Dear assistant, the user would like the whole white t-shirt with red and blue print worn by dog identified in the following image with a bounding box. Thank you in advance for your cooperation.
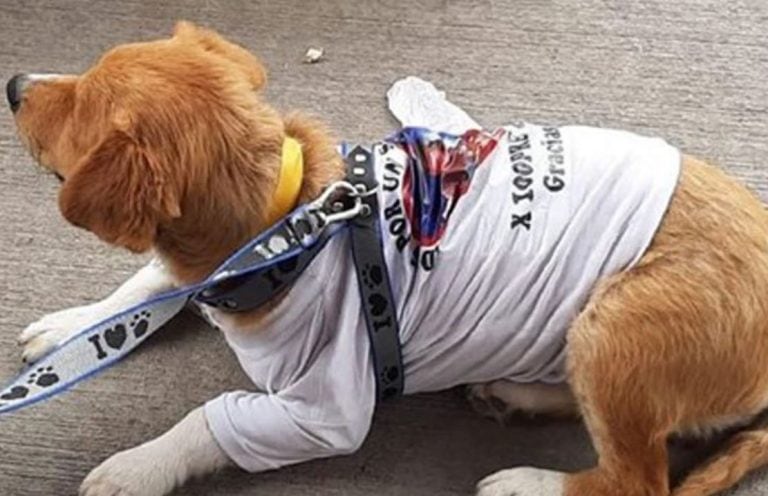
[206,123,680,471]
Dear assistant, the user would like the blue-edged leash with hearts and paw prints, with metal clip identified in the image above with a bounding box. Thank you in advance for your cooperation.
[0,182,369,414]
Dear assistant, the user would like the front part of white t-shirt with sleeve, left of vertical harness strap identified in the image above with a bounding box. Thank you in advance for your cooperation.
[205,236,376,472]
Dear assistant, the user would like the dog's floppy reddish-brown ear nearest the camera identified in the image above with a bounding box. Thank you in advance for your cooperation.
[59,130,181,252]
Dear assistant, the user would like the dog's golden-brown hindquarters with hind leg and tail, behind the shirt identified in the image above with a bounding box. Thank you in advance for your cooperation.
[478,159,768,496]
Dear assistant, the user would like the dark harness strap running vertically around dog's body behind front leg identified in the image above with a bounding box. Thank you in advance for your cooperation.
[346,146,405,400]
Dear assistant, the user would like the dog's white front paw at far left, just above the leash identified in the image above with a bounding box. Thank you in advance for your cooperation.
[19,304,104,363]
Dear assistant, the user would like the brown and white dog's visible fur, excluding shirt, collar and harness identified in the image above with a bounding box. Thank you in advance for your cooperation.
[8,22,768,496]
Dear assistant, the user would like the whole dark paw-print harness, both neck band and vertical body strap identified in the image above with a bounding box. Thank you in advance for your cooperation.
[196,146,405,400]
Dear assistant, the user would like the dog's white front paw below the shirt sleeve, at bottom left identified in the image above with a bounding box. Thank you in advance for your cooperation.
[79,445,175,496]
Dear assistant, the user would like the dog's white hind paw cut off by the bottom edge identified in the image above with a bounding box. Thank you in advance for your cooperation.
[477,467,565,496]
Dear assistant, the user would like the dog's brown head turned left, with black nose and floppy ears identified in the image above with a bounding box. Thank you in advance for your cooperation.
[7,22,283,251]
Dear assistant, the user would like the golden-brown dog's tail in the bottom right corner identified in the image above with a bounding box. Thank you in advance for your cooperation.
[672,426,768,496]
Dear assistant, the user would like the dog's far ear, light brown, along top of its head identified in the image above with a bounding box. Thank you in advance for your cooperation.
[173,21,267,90]
